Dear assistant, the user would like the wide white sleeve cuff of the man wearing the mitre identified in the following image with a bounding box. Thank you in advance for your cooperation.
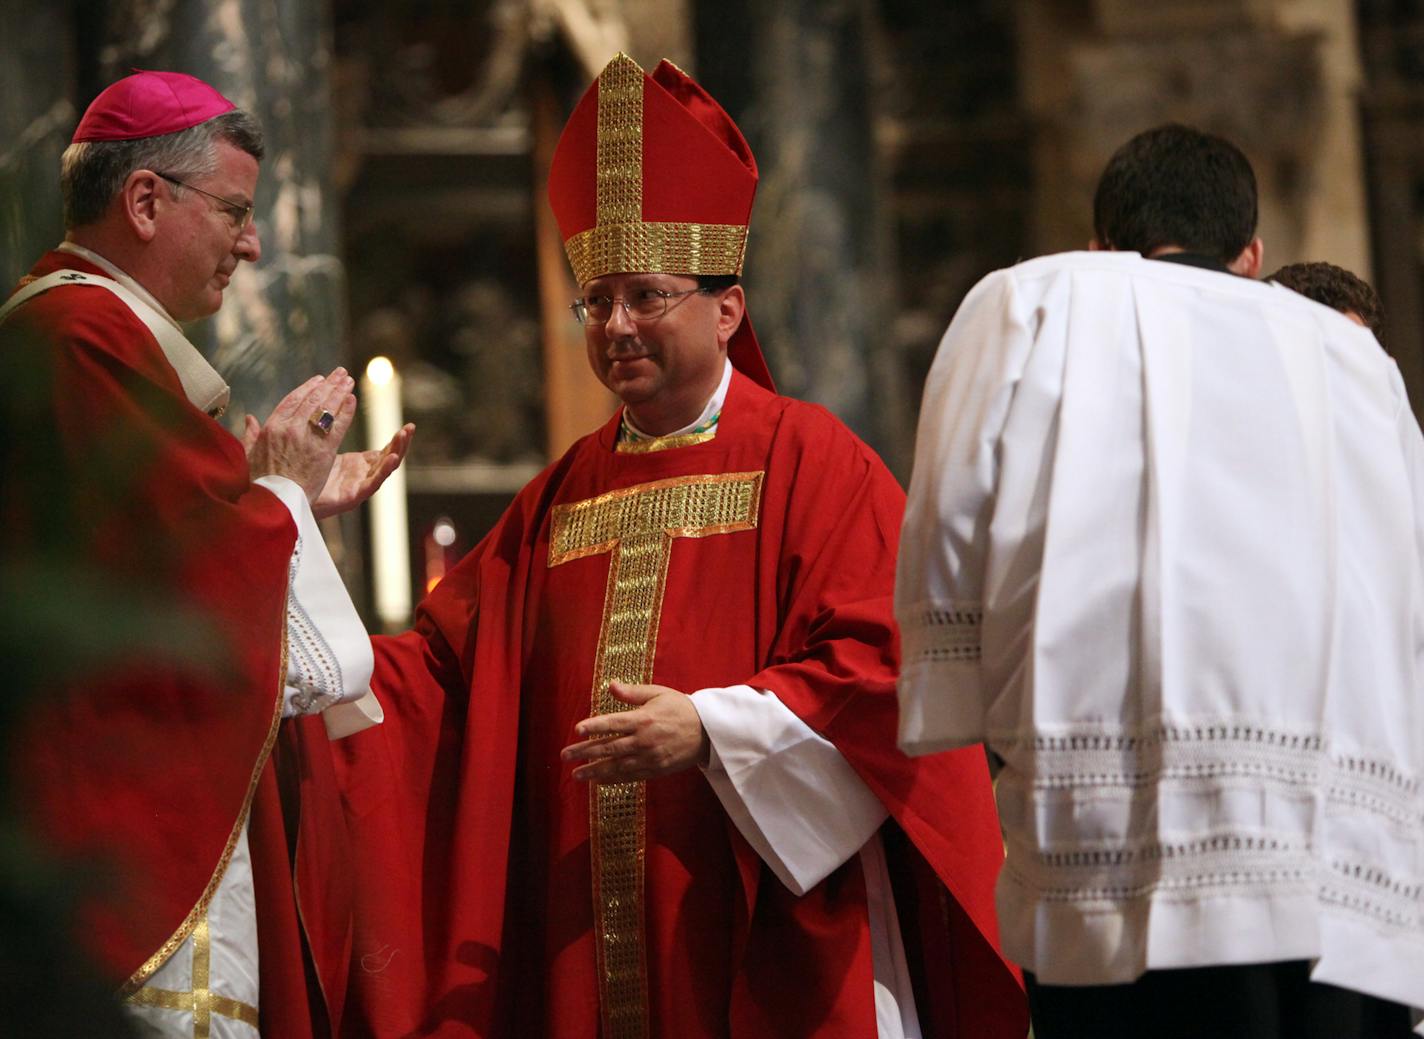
[692,686,886,895]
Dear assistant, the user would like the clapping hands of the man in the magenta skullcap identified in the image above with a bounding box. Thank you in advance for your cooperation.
[242,369,416,520]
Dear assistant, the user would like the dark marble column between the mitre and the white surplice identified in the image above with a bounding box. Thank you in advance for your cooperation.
[698,0,907,466]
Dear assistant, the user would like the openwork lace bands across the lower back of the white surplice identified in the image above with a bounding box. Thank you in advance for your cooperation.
[990,720,1424,934]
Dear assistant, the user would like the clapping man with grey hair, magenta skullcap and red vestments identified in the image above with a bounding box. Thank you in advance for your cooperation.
[0,71,409,1039]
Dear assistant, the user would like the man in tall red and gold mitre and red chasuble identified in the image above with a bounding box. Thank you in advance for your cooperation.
[335,56,1027,1039]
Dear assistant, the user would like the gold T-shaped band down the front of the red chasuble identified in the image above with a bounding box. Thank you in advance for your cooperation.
[548,473,765,1039]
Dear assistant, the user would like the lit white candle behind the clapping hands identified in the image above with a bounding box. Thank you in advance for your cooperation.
[360,357,410,631]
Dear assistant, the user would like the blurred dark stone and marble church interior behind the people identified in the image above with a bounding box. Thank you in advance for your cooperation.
[0,0,1424,509]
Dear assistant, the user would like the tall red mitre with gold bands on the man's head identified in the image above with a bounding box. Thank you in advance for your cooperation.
[548,54,772,389]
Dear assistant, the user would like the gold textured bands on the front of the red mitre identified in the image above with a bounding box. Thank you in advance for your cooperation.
[564,54,746,285]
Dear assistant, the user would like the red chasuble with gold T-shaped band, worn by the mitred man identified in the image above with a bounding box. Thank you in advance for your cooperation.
[333,374,1027,1039]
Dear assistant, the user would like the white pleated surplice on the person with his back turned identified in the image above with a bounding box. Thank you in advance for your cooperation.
[896,252,1424,1030]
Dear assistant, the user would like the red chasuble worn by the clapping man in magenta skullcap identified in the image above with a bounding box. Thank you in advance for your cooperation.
[0,252,349,1038]
